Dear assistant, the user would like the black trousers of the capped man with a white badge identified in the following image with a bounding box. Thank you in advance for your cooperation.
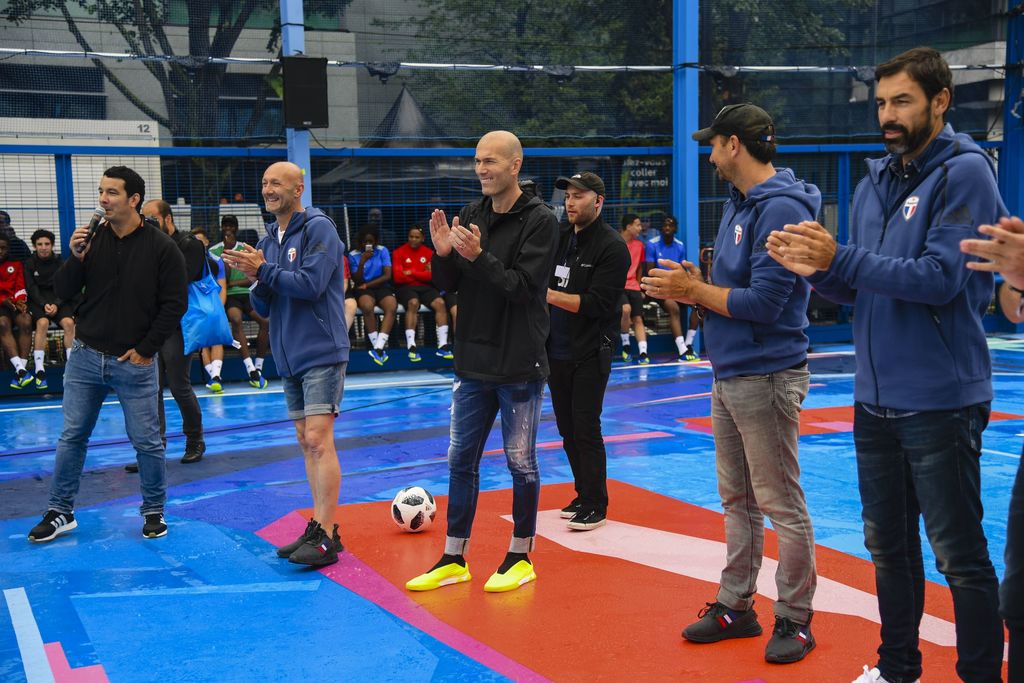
[548,346,611,512]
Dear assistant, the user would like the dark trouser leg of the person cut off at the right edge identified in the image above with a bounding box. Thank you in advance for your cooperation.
[999,453,1024,681]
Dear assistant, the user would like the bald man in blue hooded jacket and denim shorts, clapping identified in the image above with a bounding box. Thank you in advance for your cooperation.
[223,162,348,566]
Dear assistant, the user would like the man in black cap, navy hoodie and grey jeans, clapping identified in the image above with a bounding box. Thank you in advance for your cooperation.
[643,104,821,664]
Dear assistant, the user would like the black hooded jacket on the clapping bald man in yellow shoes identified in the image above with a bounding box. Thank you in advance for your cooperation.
[432,195,558,384]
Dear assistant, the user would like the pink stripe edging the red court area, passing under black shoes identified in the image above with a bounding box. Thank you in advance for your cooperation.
[256,512,549,683]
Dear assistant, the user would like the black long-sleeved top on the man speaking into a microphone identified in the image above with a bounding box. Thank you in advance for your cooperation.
[53,220,188,358]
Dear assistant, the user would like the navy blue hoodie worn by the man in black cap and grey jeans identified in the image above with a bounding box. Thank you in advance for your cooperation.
[705,168,821,379]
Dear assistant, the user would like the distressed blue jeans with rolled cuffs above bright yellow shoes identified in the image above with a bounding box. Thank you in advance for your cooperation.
[444,377,544,554]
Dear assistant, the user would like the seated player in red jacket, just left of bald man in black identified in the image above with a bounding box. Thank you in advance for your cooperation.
[392,225,452,362]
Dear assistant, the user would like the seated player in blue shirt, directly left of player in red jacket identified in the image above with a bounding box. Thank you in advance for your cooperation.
[348,232,398,366]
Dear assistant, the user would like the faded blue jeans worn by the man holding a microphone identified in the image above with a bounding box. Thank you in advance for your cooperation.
[49,339,167,515]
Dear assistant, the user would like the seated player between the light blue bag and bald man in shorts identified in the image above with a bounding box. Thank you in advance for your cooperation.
[210,219,270,391]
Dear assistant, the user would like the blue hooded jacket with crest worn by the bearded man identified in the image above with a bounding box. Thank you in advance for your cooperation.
[809,125,1007,411]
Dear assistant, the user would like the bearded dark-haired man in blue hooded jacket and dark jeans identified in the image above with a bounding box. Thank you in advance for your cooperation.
[768,47,1007,683]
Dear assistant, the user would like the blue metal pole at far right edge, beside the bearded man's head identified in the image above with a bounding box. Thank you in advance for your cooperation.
[999,0,1024,216]
